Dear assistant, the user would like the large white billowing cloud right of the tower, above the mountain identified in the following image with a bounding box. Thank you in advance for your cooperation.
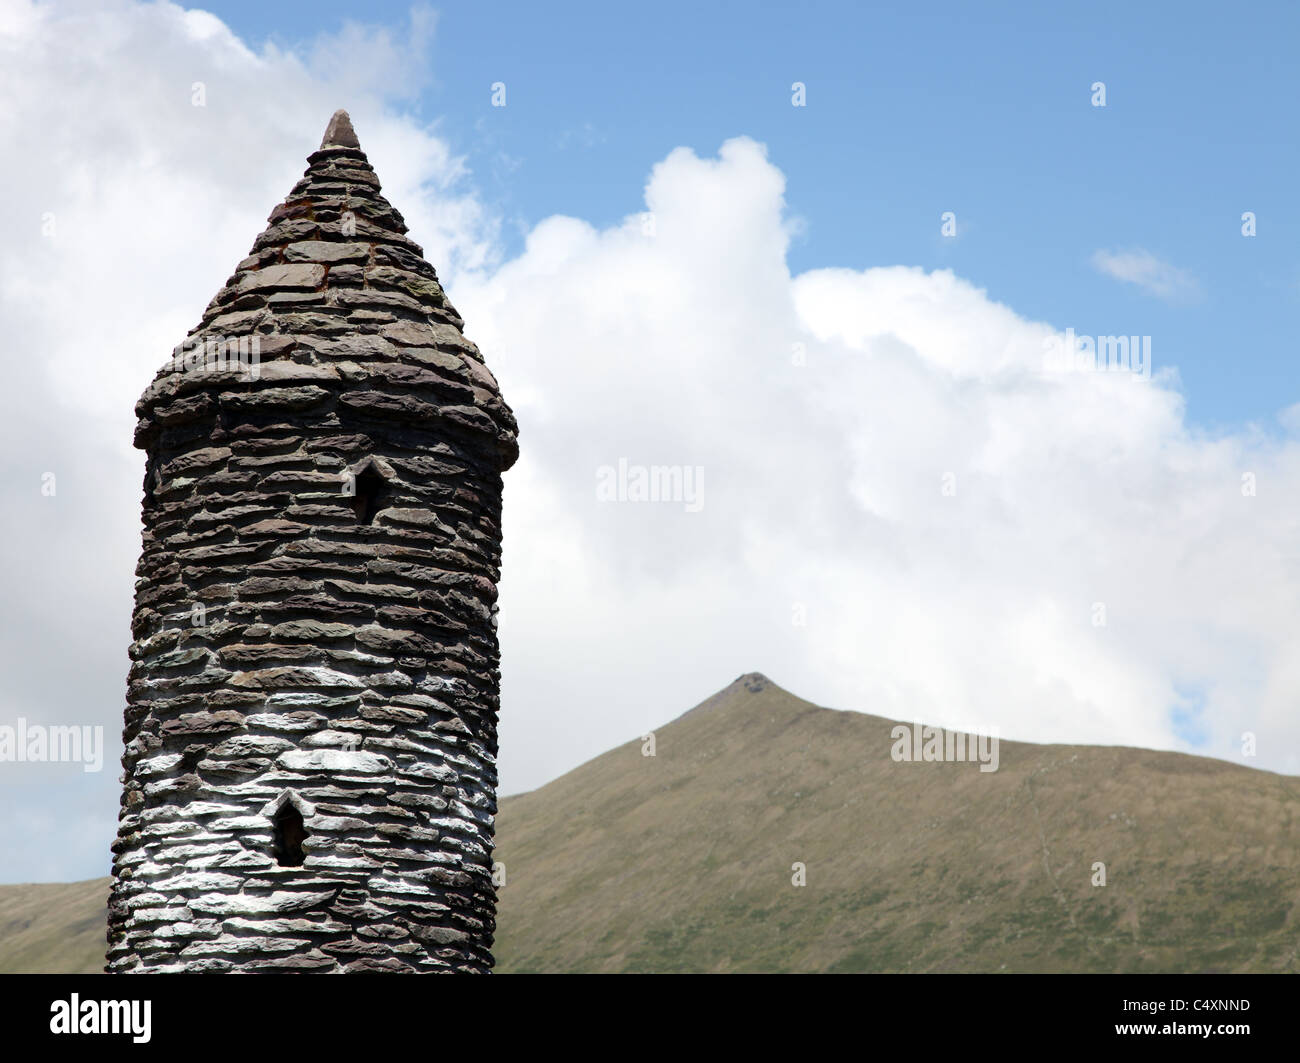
[454,149,1300,785]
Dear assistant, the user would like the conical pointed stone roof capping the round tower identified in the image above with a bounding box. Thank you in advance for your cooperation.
[135,110,519,470]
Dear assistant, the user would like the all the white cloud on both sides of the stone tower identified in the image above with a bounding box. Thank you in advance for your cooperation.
[0,3,1300,881]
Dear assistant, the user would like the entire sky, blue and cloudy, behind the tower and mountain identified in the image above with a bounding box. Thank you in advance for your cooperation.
[0,0,1300,882]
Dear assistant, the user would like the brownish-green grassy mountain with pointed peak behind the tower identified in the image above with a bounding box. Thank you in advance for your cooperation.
[0,673,1300,972]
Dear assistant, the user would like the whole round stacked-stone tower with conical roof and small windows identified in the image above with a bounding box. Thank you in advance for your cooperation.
[108,112,517,972]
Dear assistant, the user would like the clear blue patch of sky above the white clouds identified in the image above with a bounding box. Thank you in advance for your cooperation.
[209,3,1300,431]
